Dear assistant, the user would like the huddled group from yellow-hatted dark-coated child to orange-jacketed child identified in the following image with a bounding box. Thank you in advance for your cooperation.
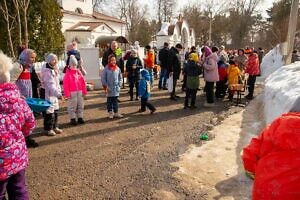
[183,46,247,109]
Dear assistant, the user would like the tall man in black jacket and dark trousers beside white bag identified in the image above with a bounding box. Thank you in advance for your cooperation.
[168,44,182,101]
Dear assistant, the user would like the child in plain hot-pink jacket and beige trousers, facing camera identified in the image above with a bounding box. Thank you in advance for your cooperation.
[63,55,87,125]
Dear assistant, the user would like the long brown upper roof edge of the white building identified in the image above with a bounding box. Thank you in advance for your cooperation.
[62,9,126,24]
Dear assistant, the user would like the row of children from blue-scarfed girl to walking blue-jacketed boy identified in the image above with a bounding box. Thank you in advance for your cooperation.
[16,46,156,136]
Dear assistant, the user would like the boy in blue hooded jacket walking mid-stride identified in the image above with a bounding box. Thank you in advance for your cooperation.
[138,69,156,114]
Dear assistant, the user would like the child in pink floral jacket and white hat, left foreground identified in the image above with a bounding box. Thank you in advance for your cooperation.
[0,53,35,200]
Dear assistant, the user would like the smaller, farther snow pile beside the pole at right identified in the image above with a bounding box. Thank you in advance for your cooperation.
[261,44,284,79]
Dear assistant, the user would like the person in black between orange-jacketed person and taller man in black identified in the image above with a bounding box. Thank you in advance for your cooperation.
[158,42,169,90]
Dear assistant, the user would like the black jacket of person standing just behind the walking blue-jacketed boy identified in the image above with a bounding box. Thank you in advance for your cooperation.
[126,56,143,81]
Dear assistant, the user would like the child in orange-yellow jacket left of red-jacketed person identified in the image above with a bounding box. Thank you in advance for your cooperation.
[227,60,241,101]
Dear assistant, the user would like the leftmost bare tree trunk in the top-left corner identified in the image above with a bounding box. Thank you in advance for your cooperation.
[0,0,15,58]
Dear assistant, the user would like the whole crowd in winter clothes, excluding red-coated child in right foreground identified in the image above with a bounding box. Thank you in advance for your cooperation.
[0,38,298,199]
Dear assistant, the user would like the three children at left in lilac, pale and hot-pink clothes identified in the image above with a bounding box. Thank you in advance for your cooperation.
[8,46,87,138]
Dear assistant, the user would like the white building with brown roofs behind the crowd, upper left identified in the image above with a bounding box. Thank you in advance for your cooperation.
[58,0,126,47]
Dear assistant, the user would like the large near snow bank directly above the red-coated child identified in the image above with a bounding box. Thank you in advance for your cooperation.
[264,62,300,124]
